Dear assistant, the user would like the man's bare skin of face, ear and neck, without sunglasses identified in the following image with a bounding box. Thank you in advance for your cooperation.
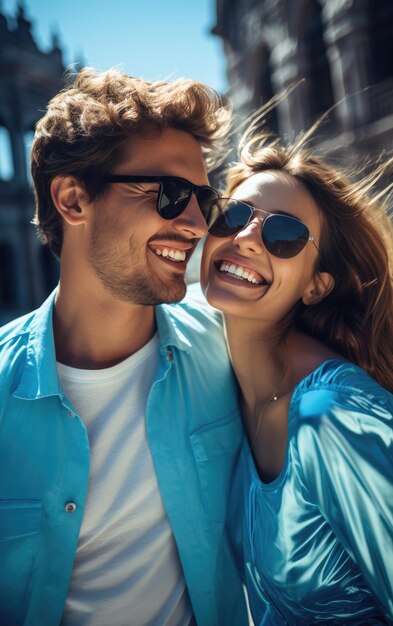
[51,129,208,369]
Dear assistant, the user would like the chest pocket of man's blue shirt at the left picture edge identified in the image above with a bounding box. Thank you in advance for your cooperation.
[0,500,42,626]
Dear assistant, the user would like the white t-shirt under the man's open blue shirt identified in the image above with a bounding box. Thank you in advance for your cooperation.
[58,336,195,626]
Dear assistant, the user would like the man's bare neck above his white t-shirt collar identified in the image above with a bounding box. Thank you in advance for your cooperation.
[53,284,156,369]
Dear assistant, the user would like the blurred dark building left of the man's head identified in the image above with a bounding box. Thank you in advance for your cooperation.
[0,4,64,323]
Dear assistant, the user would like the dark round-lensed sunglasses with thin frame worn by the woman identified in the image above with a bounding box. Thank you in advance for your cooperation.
[209,198,318,259]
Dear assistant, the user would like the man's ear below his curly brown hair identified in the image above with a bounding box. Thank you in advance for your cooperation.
[50,176,89,226]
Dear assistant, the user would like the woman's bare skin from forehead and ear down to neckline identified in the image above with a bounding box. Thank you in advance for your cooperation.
[201,171,337,482]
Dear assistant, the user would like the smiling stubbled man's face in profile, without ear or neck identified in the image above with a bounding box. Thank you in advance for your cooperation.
[88,129,208,305]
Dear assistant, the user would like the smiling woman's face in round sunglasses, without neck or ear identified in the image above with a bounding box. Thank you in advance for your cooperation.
[201,170,322,323]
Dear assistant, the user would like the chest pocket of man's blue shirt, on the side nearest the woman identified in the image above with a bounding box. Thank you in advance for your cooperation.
[190,411,243,523]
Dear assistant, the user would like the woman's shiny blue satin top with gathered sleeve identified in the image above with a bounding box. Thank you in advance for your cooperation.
[229,360,393,626]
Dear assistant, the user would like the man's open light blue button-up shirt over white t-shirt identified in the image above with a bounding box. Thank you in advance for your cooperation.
[0,292,247,626]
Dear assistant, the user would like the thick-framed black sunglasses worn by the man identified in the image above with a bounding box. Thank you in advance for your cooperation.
[104,174,220,225]
